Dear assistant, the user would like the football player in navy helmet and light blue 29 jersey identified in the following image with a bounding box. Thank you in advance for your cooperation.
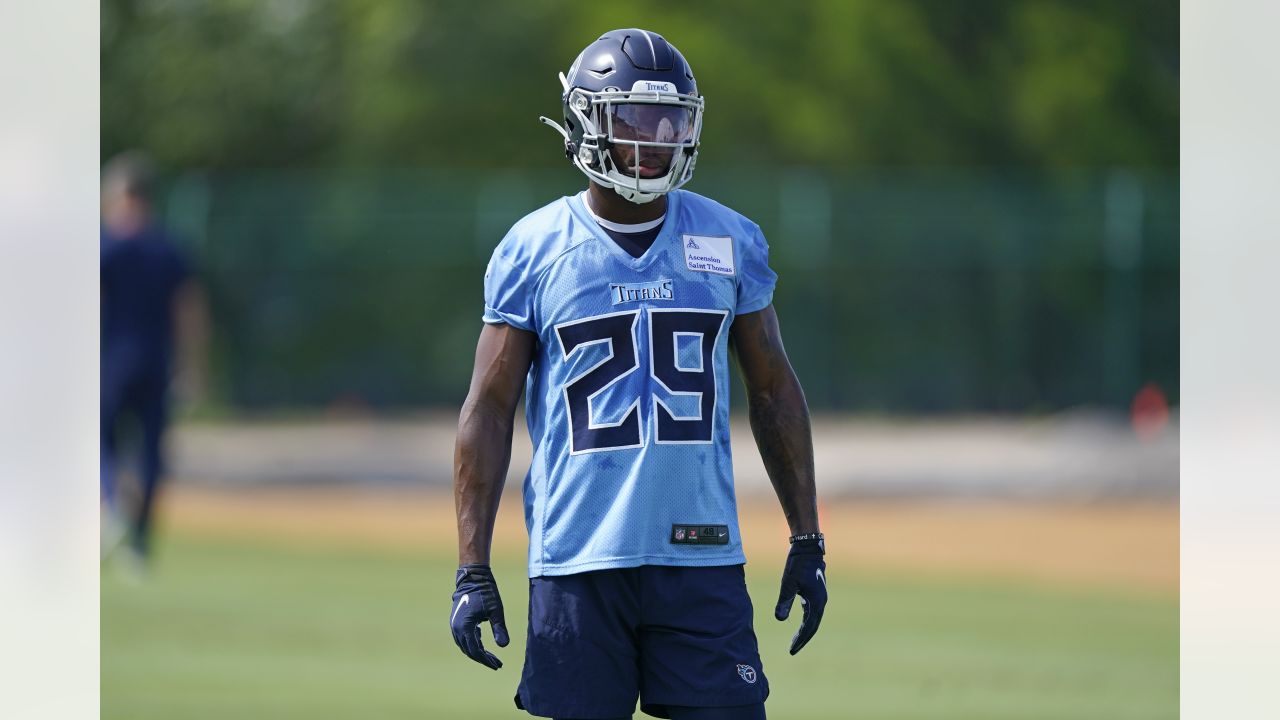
[449,29,827,720]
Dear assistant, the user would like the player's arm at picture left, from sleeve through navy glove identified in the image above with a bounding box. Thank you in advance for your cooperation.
[449,319,536,670]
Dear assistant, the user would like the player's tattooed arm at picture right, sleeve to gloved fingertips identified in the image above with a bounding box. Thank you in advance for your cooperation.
[730,299,827,655]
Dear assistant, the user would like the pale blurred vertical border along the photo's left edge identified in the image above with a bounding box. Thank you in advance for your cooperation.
[0,0,100,719]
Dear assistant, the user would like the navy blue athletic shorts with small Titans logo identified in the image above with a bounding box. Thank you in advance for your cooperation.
[516,565,769,717]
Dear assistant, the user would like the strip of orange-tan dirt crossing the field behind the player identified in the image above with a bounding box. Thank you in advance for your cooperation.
[163,486,1179,593]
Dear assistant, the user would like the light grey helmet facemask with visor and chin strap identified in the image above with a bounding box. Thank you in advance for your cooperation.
[541,74,703,204]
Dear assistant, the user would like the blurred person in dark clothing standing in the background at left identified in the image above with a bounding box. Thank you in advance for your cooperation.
[100,150,197,569]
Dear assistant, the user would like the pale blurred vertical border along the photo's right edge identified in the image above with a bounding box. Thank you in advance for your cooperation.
[1179,0,1280,719]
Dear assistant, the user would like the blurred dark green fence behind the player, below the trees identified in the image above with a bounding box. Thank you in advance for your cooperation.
[166,165,1179,413]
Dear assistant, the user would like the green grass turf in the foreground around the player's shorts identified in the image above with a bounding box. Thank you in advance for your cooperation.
[102,536,1178,720]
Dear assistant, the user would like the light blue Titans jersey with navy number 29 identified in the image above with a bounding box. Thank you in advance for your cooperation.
[484,191,777,577]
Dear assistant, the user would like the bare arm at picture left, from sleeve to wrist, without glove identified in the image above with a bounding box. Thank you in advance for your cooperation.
[453,324,536,565]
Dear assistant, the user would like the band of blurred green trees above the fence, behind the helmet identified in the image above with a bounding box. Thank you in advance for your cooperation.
[101,0,1178,169]
